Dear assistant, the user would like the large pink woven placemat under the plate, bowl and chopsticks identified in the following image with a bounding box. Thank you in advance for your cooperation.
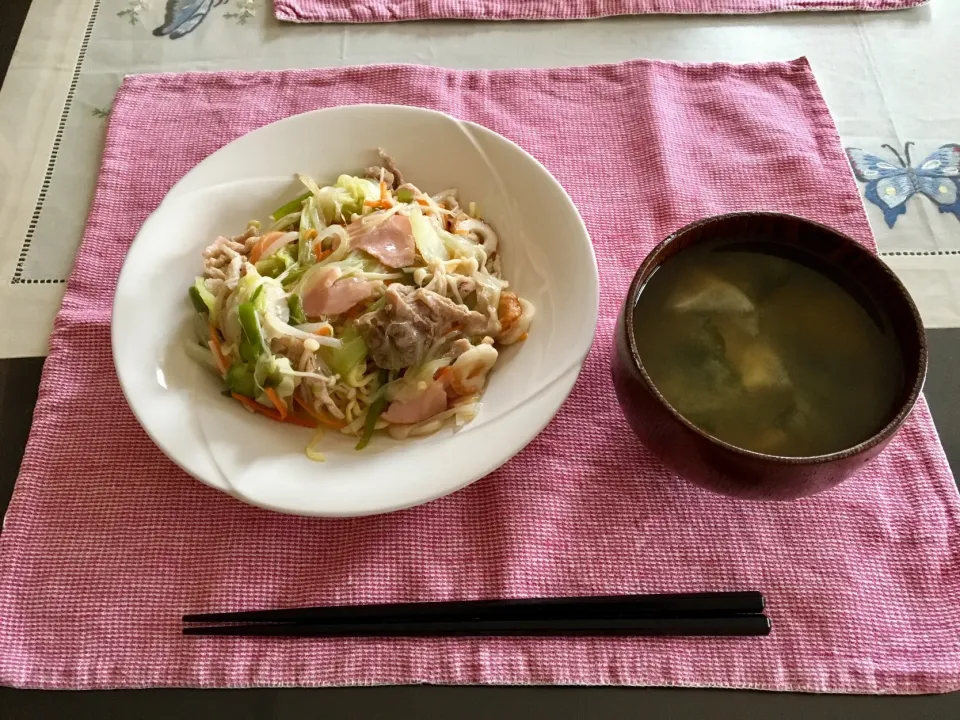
[0,60,960,693]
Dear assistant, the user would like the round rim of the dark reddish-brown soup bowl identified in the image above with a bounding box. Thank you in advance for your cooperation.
[622,210,928,466]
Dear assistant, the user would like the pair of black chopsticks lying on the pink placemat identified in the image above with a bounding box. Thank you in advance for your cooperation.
[183,591,770,637]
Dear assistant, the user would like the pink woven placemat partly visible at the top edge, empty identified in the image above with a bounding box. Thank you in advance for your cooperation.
[273,0,929,23]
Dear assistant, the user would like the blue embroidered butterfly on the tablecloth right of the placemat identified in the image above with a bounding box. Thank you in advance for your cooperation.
[847,142,960,228]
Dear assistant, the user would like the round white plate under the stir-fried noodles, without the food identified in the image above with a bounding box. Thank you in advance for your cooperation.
[112,105,599,516]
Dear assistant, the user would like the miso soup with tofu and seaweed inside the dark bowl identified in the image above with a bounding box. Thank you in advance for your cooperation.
[634,240,904,457]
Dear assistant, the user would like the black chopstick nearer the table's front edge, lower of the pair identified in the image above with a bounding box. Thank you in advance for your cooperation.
[183,615,770,637]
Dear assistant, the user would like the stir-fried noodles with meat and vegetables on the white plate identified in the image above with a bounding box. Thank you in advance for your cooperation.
[189,150,534,460]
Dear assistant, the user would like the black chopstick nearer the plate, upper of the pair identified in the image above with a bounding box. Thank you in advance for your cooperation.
[183,591,764,623]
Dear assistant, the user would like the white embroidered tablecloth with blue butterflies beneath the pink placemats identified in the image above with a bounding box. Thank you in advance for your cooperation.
[0,0,960,357]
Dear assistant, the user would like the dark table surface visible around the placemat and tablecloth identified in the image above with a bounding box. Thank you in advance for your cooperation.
[0,0,960,720]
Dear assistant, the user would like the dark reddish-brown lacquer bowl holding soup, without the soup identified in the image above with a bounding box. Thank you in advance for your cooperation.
[612,212,927,500]
